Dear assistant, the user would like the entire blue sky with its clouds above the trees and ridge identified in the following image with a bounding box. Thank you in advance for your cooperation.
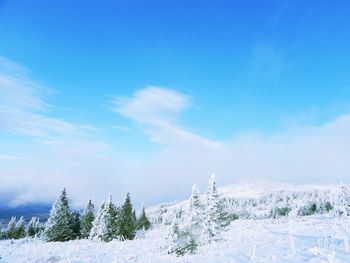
[0,0,350,207]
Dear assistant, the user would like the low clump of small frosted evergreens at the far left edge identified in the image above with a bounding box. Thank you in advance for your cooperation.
[0,217,44,239]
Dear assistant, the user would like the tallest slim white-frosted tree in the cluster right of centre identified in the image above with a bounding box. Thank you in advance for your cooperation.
[203,174,222,243]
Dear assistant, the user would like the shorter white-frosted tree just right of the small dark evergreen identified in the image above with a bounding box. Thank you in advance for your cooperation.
[89,202,108,241]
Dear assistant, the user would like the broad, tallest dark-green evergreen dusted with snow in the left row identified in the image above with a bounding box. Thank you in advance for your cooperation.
[44,189,74,241]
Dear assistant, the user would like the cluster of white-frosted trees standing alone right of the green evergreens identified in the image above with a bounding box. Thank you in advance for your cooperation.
[166,175,235,255]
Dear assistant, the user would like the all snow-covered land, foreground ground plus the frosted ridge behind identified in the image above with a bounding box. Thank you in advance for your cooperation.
[0,180,350,263]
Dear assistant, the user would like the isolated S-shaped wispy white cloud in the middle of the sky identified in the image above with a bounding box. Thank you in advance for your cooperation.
[112,86,219,147]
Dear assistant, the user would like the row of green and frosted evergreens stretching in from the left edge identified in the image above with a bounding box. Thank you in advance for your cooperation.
[0,189,151,242]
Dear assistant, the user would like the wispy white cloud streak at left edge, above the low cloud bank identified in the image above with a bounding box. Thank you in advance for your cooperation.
[0,58,81,137]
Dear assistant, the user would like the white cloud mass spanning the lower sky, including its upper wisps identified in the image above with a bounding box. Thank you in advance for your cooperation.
[0,59,350,208]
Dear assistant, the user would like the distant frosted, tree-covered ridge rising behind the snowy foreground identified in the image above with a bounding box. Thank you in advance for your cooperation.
[147,182,350,225]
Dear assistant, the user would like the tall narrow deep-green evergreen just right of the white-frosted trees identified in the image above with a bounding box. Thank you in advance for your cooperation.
[119,193,136,240]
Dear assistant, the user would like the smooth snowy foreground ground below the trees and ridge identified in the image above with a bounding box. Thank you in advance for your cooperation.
[0,215,350,263]
